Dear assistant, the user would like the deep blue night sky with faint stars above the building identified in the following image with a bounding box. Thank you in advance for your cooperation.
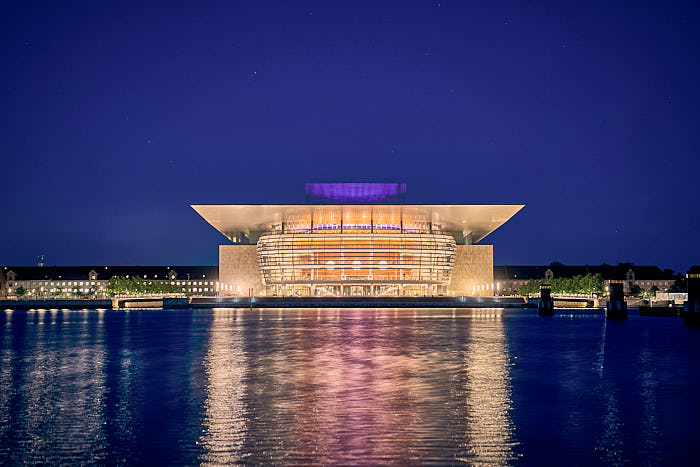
[0,0,700,271]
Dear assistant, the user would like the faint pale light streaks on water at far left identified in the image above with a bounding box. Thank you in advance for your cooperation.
[0,310,106,463]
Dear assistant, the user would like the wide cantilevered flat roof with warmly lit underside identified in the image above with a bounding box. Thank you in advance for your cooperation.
[192,204,525,242]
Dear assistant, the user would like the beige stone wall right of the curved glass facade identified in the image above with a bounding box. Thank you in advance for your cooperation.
[447,245,494,296]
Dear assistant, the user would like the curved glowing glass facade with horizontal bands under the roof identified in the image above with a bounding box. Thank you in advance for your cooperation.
[257,233,455,294]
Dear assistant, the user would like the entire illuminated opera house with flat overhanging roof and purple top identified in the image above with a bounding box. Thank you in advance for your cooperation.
[192,183,523,296]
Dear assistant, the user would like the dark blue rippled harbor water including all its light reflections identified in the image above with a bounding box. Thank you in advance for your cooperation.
[0,309,700,465]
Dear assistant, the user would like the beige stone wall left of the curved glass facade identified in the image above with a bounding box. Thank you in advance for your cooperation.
[219,245,265,297]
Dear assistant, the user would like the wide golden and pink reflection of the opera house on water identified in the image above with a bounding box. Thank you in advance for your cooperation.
[194,310,517,464]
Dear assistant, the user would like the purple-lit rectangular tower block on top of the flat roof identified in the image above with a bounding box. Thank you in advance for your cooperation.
[306,183,406,204]
